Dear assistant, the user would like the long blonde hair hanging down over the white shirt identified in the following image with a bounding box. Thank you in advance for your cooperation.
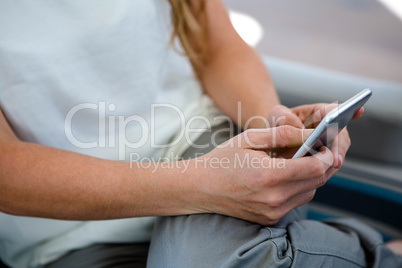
[169,0,208,78]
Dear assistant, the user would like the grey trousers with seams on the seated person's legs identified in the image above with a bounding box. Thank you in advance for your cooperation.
[147,124,402,268]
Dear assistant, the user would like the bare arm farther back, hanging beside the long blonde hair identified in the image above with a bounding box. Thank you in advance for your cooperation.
[196,0,279,128]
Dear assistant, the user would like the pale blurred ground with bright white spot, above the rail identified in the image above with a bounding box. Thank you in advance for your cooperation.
[225,0,402,83]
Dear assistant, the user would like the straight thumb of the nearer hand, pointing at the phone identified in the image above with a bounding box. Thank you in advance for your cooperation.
[242,125,313,150]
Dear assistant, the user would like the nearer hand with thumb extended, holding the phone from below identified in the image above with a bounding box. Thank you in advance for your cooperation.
[190,126,334,225]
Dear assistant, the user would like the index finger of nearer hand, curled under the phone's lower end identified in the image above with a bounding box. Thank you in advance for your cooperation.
[267,146,333,182]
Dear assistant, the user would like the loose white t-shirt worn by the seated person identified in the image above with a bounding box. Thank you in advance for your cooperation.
[0,0,223,267]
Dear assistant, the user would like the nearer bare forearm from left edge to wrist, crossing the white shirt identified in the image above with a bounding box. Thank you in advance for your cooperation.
[0,142,198,220]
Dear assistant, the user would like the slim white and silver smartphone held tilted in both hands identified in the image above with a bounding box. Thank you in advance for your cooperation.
[293,89,372,158]
